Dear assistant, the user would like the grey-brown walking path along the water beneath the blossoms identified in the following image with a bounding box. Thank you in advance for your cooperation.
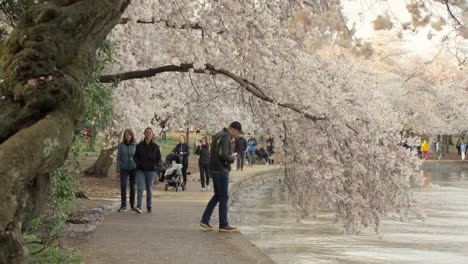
[66,165,277,264]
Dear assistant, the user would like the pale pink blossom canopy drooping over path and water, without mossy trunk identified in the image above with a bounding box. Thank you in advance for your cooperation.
[101,1,466,232]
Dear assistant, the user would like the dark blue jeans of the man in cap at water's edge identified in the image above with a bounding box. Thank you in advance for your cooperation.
[202,171,229,229]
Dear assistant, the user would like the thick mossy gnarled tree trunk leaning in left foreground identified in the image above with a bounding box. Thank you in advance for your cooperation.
[0,0,129,264]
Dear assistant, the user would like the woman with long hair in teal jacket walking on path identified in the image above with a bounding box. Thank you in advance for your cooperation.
[116,129,136,212]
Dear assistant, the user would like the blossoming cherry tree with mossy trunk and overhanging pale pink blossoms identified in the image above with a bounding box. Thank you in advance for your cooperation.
[0,0,467,263]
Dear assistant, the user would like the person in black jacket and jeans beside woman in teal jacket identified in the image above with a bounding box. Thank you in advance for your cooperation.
[133,127,161,214]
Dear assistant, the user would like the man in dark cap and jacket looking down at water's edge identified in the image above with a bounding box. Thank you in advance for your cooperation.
[200,121,242,232]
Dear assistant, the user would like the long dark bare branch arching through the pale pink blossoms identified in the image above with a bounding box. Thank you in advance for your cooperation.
[99,64,325,121]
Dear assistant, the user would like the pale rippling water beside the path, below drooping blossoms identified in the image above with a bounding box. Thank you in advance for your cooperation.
[231,163,468,264]
